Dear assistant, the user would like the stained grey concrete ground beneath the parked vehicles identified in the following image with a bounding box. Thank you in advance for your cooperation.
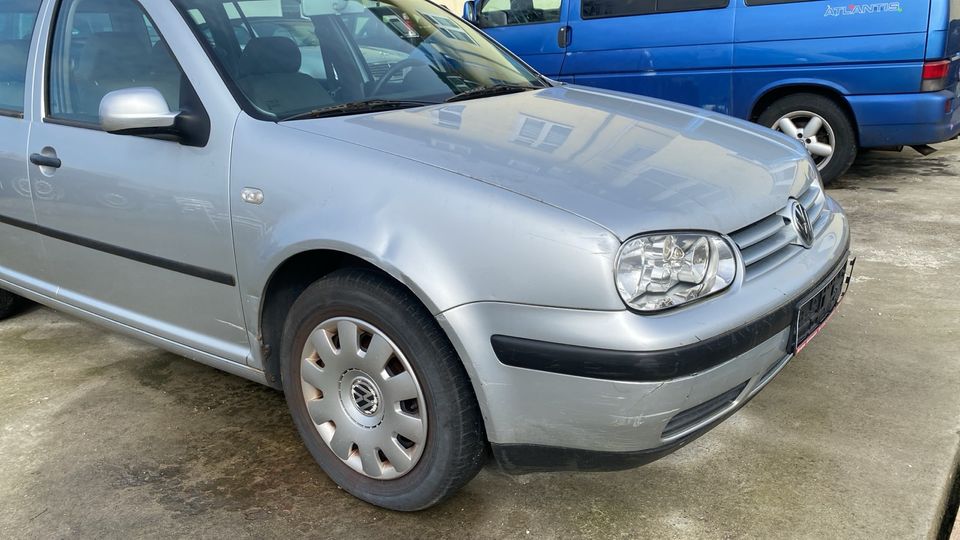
[0,143,960,538]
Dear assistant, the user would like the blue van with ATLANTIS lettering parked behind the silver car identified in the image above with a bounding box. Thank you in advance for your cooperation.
[464,0,960,181]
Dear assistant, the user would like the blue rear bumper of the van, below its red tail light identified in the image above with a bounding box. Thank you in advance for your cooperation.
[847,86,960,148]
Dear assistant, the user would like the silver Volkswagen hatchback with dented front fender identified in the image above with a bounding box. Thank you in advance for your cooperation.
[0,0,850,510]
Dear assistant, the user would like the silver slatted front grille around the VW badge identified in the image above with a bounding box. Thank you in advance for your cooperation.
[730,182,830,280]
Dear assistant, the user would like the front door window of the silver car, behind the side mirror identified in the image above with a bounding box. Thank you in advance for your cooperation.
[48,0,183,124]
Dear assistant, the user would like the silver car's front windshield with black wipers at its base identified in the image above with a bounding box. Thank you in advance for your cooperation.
[175,0,546,121]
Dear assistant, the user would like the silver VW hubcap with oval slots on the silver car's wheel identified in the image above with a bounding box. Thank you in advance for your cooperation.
[300,317,427,480]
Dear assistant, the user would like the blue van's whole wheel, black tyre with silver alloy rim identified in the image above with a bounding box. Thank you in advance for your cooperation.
[757,94,857,184]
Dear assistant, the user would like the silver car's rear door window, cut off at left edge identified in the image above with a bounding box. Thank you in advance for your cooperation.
[0,0,40,115]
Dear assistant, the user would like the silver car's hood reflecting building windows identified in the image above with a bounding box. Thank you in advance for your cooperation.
[284,86,815,239]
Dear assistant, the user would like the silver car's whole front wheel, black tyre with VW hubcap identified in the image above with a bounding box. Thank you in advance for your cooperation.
[281,269,486,511]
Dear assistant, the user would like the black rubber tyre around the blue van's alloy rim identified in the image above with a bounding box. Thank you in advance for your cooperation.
[757,93,857,185]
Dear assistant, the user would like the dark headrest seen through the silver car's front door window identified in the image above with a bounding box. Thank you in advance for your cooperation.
[77,32,150,80]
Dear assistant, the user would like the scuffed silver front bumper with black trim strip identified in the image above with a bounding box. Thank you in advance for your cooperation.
[439,203,849,472]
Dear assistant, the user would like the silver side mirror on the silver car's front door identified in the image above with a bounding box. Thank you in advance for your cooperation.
[100,87,179,134]
